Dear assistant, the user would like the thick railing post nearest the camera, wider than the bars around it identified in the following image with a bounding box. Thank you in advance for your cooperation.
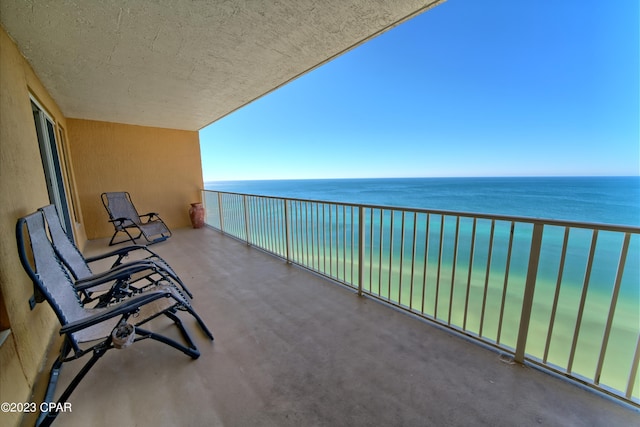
[514,222,544,363]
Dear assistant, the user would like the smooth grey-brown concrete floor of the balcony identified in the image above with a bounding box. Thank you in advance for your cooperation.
[32,229,640,426]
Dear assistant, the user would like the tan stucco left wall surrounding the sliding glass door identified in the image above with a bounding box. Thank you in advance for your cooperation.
[0,28,70,426]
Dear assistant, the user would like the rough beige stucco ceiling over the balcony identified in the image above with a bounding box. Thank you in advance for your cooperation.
[0,0,443,130]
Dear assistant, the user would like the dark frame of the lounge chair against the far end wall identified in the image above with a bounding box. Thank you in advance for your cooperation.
[100,191,171,246]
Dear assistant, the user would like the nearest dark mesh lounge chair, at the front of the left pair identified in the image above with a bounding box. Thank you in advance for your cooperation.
[16,211,213,426]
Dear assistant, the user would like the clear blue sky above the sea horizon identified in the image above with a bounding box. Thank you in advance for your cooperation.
[200,0,640,181]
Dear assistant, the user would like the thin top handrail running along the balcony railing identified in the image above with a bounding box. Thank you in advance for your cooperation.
[203,189,640,234]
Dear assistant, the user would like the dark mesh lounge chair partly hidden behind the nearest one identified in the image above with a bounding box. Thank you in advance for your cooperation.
[39,205,193,303]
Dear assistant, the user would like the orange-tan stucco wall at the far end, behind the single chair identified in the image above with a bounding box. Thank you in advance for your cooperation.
[67,119,203,239]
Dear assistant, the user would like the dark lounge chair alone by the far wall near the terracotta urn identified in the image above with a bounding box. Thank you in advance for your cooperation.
[100,191,171,246]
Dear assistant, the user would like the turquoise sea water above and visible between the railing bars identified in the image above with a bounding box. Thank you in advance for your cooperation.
[206,177,640,399]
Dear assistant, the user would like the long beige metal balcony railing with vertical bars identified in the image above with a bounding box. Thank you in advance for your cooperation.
[204,190,640,406]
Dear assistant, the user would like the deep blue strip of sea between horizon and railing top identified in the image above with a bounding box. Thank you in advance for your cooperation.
[205,176,640,226]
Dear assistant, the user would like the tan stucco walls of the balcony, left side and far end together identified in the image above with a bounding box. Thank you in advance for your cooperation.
[0,27,203,426]
